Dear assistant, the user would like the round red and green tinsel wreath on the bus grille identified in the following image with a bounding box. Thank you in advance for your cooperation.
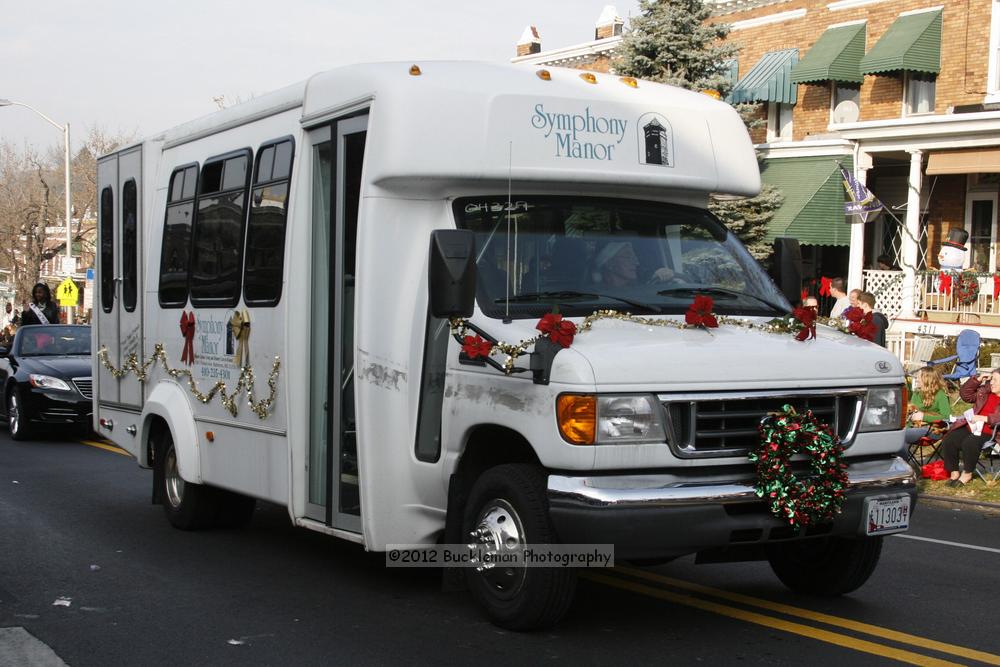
[749,405,848,530]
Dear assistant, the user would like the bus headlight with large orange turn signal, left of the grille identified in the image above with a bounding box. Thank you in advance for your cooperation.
[556,394,666,445]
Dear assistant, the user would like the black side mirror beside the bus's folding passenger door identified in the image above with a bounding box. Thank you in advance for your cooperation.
[427,229,476,319]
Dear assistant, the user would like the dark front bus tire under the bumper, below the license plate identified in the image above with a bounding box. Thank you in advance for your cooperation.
[768,537,882,597]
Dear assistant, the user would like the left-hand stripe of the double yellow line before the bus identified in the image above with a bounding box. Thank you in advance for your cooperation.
[583,572,960,667]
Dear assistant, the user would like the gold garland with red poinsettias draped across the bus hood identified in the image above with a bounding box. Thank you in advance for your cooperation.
[451,295,875,375]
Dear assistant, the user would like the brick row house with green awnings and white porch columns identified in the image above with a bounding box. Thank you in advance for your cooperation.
[528,0,1000,350]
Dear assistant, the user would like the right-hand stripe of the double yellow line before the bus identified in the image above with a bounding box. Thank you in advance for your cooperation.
[615,566,1000,665]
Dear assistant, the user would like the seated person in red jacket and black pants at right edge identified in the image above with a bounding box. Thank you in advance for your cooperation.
[941,368,1000,486]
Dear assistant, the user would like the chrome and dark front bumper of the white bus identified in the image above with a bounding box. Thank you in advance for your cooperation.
[548,457,917,558]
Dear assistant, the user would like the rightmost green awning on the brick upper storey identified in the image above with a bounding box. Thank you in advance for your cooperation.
[861,9,941,74]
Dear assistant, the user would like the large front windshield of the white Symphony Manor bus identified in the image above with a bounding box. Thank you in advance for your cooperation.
[455,196,791,318]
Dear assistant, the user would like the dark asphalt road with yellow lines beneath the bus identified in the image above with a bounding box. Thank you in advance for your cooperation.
[0,431,1000,667]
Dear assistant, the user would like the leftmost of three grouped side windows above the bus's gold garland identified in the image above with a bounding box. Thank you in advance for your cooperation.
[159,165,198,308]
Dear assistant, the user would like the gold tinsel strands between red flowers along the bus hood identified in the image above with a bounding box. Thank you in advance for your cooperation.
[450,310,850,375]
